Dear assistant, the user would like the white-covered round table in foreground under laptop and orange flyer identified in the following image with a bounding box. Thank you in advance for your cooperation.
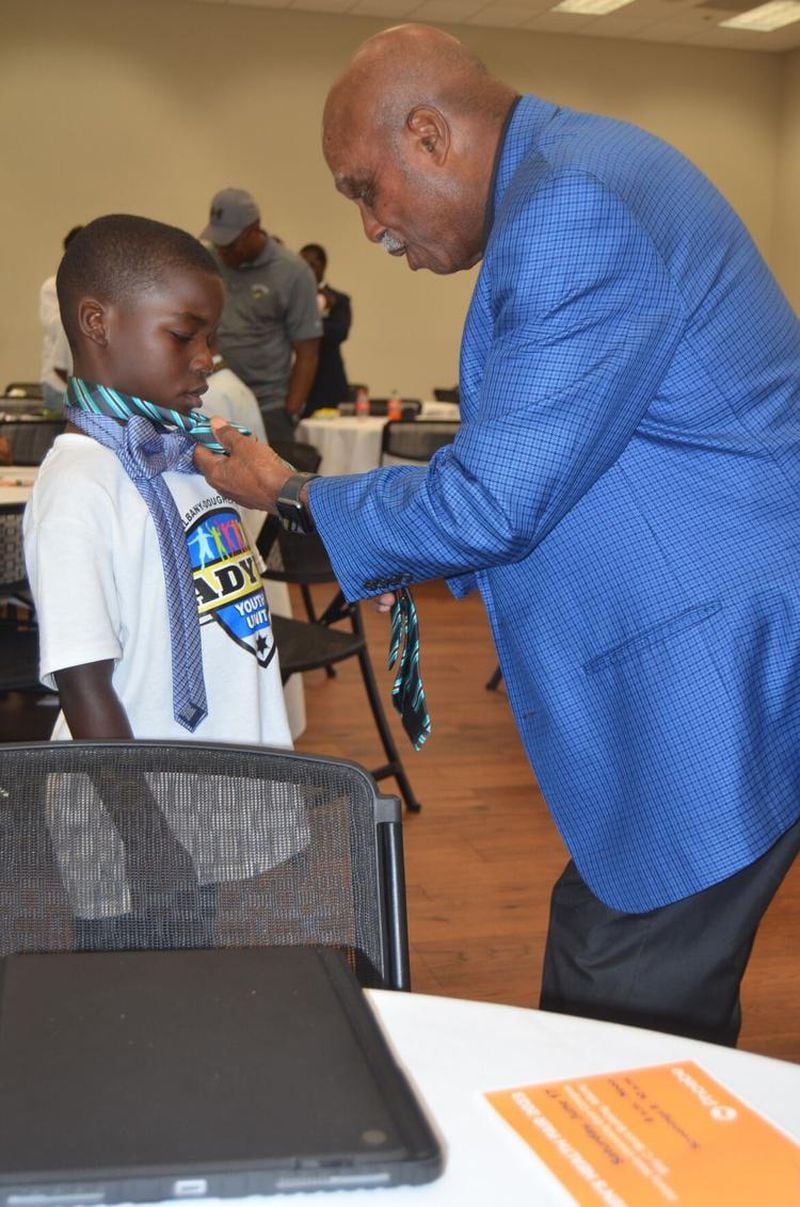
[142,990,800,1207]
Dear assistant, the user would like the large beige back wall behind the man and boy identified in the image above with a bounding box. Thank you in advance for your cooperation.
[0,0,786,396]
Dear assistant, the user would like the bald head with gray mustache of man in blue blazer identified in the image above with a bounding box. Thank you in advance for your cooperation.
[323,25,515,273]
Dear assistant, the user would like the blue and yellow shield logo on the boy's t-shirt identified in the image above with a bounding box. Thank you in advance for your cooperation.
[186,507,275,666]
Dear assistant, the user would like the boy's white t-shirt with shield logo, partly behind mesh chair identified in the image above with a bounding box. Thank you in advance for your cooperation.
[23,433,308,916]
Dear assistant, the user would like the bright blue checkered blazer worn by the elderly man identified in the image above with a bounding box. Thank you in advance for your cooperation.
[311,97,800,912]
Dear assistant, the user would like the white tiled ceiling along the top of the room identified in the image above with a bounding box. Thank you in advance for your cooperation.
[198,0,800,52]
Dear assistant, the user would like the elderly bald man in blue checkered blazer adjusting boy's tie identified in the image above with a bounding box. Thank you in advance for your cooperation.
[198,27,800,1043]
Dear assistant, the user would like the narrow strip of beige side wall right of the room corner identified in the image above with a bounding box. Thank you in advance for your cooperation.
[772,51,800,311]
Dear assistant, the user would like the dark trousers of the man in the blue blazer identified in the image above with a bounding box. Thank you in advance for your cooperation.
[539,822,800,1046]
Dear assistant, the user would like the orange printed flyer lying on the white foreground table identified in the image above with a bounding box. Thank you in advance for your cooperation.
[486,1061,800,1207]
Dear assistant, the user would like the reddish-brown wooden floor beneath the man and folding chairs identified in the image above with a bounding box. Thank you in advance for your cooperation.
[298,584,800,1061]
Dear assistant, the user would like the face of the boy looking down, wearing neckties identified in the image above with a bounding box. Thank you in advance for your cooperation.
[103,268,224,415]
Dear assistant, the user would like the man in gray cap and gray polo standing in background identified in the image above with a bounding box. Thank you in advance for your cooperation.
[200,188,322,441]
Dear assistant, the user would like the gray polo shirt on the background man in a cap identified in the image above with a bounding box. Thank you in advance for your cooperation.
[211,238,322,410]
